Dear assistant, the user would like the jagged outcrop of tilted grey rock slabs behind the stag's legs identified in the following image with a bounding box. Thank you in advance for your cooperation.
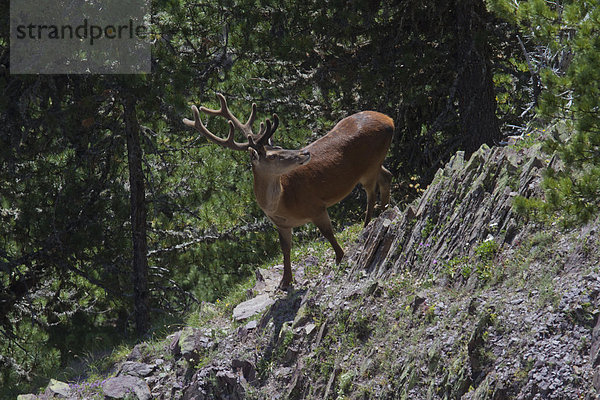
[349,145,546,278]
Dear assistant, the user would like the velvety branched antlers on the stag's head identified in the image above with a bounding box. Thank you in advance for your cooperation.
[183,93,279,150]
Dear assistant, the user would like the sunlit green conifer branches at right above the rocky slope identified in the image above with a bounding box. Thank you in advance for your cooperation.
[490,0,600,222]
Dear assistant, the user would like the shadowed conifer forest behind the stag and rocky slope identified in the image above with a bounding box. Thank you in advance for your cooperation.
[0,0,600,396]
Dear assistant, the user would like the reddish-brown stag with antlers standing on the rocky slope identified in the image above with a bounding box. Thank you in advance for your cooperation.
[183,94,394,289]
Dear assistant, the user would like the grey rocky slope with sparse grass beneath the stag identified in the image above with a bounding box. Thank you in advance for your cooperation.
[22,142,600,400]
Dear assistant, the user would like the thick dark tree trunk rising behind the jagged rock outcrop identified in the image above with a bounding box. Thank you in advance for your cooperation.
[455,0,500,155]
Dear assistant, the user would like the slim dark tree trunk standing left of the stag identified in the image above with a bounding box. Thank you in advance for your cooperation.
[123,95,150,336]
